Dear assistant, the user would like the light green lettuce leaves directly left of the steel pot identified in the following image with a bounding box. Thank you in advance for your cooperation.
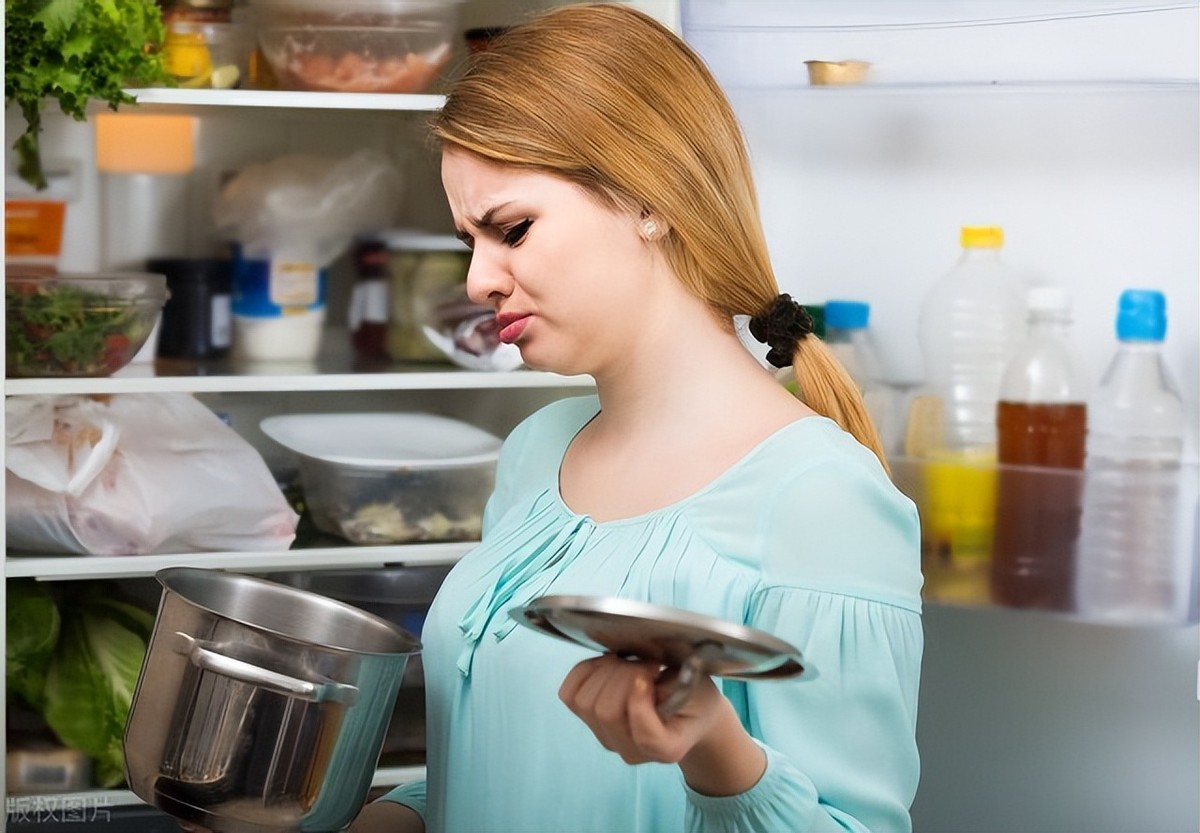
[42,587,154,787]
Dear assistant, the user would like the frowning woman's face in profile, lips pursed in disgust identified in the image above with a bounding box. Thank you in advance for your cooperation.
[442,148,661,374]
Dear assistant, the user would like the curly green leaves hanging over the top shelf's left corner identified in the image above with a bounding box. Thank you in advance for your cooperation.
[4,0,170,190]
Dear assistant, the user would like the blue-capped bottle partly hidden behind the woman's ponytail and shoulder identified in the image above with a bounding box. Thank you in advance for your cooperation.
[824,300,901,451]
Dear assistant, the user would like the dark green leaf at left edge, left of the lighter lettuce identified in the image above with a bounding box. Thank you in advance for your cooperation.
[5,580,60,708]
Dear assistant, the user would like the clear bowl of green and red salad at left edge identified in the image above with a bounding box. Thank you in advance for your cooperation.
[5,282,154,377]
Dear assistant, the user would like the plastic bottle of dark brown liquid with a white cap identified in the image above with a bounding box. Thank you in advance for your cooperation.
[991,287,1088,611]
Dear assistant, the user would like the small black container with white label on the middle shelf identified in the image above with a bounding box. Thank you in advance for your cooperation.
[146,258,233,359]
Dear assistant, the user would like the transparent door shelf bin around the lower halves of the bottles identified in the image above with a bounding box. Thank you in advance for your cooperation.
[890,457,1200,627]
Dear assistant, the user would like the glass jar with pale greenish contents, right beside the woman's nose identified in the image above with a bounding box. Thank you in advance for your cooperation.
[382,229,470,361]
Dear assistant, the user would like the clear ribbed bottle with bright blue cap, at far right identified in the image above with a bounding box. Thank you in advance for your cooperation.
[1079,289,1189,622]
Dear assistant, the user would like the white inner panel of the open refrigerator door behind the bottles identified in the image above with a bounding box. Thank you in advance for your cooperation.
[683,0,1200,833]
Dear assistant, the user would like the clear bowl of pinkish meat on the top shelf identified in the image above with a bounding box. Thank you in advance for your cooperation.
[251,0,460,92]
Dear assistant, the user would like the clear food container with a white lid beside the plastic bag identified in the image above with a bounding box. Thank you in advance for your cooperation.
[260,413,500,544]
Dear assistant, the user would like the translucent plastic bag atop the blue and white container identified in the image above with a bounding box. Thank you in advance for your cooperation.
[212,149,402,266]
